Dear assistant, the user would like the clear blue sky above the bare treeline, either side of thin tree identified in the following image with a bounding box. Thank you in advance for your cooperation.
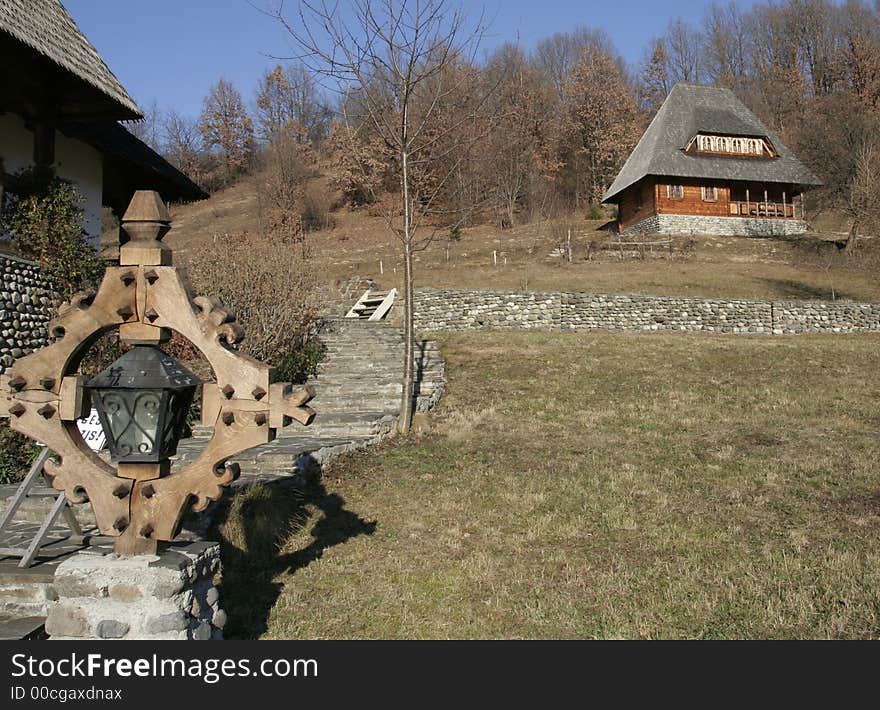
[62,0,752,116]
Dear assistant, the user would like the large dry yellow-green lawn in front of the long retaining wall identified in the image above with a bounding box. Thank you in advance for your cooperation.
[218,333,880,638]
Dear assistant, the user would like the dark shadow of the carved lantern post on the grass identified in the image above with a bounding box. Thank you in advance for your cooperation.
[217,458,376,639]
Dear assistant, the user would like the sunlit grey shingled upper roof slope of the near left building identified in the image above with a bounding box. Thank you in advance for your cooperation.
[0,0,143,119]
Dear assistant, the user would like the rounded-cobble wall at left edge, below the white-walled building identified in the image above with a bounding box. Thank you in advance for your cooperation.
[0,254,55,373]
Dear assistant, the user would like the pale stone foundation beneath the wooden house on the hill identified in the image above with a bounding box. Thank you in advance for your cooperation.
[621,214,809,237]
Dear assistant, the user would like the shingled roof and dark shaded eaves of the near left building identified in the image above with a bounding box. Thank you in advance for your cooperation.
[0,0,207,243]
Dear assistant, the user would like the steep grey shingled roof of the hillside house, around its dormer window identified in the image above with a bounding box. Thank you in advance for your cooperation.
[602,84,822,202]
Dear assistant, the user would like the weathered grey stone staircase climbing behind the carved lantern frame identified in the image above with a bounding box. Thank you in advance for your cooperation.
[178,318,446,479]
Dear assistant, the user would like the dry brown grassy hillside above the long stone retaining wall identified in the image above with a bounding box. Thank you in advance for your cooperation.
[167,181,880,301]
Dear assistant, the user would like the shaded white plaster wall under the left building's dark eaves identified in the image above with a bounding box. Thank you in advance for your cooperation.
[0,113,104,247]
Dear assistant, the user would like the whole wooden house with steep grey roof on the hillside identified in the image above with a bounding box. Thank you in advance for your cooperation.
[602,84,821,236]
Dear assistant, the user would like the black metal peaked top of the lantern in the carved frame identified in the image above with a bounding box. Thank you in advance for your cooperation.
[86,345,201,390]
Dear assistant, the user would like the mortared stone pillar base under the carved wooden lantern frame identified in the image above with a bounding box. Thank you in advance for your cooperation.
[46,542,226,641]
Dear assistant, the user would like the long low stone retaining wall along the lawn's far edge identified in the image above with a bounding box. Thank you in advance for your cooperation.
[415,289,880,335]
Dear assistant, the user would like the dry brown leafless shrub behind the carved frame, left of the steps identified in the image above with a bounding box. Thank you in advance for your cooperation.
[188,233,321,378]
